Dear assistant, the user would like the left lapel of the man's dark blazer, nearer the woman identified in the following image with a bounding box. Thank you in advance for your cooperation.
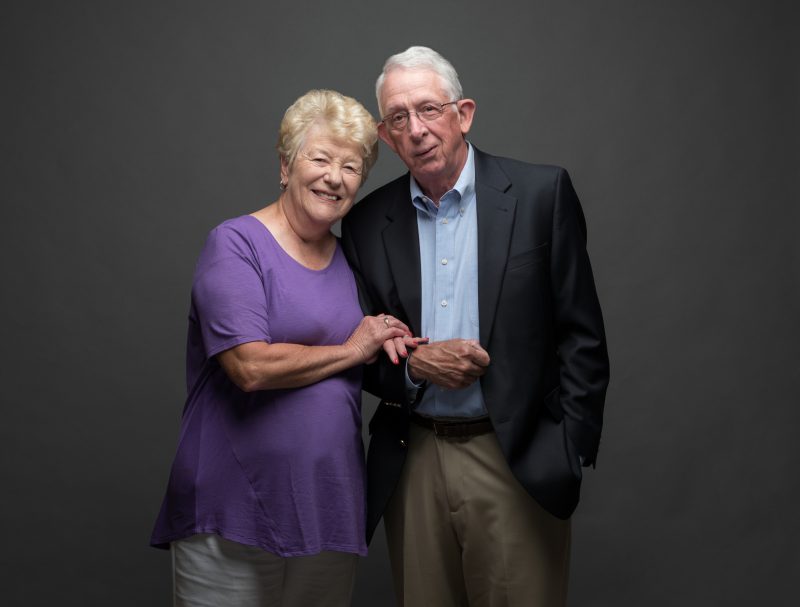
[383,178,422,335]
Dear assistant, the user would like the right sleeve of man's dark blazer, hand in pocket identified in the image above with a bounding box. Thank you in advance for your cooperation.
[550,169,609,465]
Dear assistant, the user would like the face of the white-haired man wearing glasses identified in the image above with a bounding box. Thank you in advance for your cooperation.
[378,68,475,195]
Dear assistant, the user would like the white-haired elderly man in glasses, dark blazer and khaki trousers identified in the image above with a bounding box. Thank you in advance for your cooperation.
[342,47,608,607]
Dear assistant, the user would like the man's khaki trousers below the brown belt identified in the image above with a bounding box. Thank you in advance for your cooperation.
[384,423,570,607]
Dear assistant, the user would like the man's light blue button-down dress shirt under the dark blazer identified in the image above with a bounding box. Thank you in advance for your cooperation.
[411,144,487,417]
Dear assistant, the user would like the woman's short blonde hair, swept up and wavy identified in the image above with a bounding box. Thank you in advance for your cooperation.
[276,89,378,183]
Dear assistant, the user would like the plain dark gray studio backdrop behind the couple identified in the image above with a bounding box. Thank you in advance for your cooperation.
[0,0,800,606]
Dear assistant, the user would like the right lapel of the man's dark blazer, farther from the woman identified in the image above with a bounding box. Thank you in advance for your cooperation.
[476,146,517,347]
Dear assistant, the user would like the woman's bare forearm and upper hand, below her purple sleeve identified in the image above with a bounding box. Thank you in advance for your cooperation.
[217,316,410,392]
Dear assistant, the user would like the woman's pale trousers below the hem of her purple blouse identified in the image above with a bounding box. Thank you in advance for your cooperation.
[170,533,358,607]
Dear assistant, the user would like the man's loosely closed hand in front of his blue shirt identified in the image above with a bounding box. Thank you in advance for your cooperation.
[408,339,489,389]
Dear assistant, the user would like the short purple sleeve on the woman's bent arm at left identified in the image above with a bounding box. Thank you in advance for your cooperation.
[192,224,270,358]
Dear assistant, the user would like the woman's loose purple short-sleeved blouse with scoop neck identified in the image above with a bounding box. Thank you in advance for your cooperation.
[150,215,367,556]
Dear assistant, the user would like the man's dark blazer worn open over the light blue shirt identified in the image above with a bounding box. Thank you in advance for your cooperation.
[342,149,609,539]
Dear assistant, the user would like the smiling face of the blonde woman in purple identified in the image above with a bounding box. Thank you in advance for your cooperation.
[281,125,364,228]
